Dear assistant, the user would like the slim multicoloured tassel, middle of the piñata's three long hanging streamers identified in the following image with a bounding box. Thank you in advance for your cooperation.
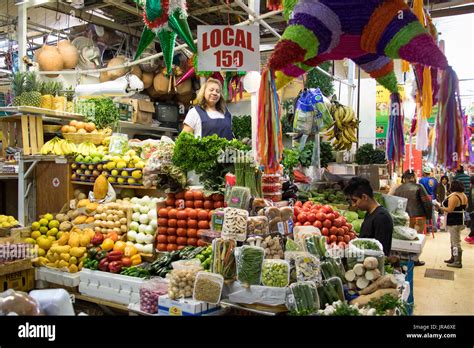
[387,93,405,164]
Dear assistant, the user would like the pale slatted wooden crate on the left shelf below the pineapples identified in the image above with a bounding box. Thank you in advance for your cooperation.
[0,115,44,155]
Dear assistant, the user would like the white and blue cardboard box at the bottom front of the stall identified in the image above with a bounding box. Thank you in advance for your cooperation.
[158,295,220,316]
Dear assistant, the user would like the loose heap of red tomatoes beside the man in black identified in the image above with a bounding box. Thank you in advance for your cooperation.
[294,201,356,248]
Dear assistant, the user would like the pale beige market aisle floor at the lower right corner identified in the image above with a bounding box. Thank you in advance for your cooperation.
[414,229,474,315]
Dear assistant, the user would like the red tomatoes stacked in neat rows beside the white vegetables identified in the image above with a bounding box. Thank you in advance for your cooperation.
[156,190,224,251]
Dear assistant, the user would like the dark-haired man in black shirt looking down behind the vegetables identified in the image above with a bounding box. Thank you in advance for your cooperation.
[344,177,393,256]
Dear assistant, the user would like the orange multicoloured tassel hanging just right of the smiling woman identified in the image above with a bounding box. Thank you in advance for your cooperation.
[257,70,283,173]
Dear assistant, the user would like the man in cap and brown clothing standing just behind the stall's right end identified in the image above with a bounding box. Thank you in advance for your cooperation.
[394,170,433,266]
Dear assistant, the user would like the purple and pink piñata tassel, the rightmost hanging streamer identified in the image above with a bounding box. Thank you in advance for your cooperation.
[436,68,466,169]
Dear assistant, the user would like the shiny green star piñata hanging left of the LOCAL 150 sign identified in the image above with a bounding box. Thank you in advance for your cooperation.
[135,0,197,75]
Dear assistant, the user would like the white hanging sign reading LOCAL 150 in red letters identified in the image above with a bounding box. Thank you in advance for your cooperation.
[198,25,260,71]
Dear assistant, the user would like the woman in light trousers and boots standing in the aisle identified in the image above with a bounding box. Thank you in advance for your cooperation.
[439,180,468,268]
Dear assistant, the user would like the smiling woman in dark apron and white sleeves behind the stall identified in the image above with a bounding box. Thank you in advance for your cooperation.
[183,78,234,140]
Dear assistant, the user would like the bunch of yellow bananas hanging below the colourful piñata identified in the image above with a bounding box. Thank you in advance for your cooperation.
[326,100,360,151]
